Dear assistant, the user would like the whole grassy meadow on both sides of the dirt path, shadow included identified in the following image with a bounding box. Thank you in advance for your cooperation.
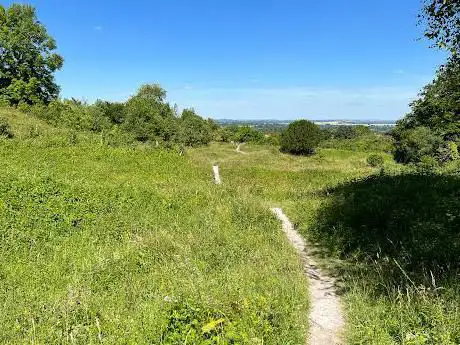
[0,110,460,345]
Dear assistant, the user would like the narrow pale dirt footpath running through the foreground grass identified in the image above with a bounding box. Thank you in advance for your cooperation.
[272,208,344,345]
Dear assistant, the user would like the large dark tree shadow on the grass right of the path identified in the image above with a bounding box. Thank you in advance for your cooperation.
[310,174,460,286]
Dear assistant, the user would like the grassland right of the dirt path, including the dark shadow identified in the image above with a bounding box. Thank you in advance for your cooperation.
[191,144,460,345]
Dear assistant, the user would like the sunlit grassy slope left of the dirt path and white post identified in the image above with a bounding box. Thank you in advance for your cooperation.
[0,109,307,344]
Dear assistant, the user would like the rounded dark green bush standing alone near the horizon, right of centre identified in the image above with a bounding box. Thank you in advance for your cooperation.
[280,120,322,154]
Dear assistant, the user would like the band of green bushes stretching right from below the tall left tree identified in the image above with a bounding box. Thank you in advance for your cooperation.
[20,85,221,147]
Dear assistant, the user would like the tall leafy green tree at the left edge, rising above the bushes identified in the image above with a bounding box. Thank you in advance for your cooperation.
[0,4,64,105]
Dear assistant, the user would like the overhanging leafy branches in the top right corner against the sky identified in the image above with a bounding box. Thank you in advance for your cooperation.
[419,0,460,55]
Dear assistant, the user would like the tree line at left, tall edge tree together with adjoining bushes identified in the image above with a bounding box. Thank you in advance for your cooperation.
[0,4,220,146]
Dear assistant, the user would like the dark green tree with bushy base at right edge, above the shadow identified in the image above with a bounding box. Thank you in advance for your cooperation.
[392,56,460,163]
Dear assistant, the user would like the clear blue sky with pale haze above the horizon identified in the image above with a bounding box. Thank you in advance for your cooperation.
[0,0,444,120]
